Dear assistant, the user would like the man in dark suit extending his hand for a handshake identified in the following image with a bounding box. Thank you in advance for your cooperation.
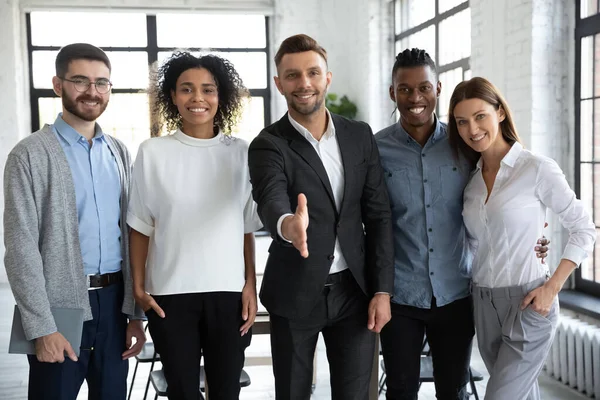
[249,35,394,400]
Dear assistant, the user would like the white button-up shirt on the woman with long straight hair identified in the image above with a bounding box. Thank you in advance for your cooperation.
[463,143,596,288]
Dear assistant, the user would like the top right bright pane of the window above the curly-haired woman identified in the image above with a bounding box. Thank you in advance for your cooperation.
[156,13,267,48]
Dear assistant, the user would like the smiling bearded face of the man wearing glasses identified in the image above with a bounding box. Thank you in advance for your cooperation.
[52,59,110,122]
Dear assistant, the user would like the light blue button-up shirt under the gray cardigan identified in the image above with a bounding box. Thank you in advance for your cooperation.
[53,113,125,275]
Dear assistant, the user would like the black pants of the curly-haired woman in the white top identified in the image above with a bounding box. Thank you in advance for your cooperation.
[146,292,252,400]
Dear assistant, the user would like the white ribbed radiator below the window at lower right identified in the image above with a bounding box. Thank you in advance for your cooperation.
[545,315,600,399]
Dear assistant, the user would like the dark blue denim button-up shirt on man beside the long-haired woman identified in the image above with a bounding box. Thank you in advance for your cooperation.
[375,121,472,308]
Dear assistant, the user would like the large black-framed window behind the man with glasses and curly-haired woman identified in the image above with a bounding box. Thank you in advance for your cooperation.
[27,11,271,156]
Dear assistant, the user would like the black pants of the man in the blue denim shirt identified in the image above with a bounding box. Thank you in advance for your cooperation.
[381,296,475,400]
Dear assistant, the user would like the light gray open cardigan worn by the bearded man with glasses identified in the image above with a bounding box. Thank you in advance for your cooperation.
[4,125,143,340]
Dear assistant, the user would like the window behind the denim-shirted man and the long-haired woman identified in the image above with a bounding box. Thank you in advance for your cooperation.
[394,0,471,121]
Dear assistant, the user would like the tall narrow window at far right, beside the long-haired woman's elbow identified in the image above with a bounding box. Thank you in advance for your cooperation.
[575,0,600,296]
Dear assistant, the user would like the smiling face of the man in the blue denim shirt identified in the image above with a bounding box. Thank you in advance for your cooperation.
[390,65,442,130]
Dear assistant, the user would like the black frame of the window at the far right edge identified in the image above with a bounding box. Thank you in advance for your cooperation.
[574,0,600,297]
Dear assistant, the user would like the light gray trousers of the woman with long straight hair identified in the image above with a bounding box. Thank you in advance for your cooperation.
[473,278,559,400]
